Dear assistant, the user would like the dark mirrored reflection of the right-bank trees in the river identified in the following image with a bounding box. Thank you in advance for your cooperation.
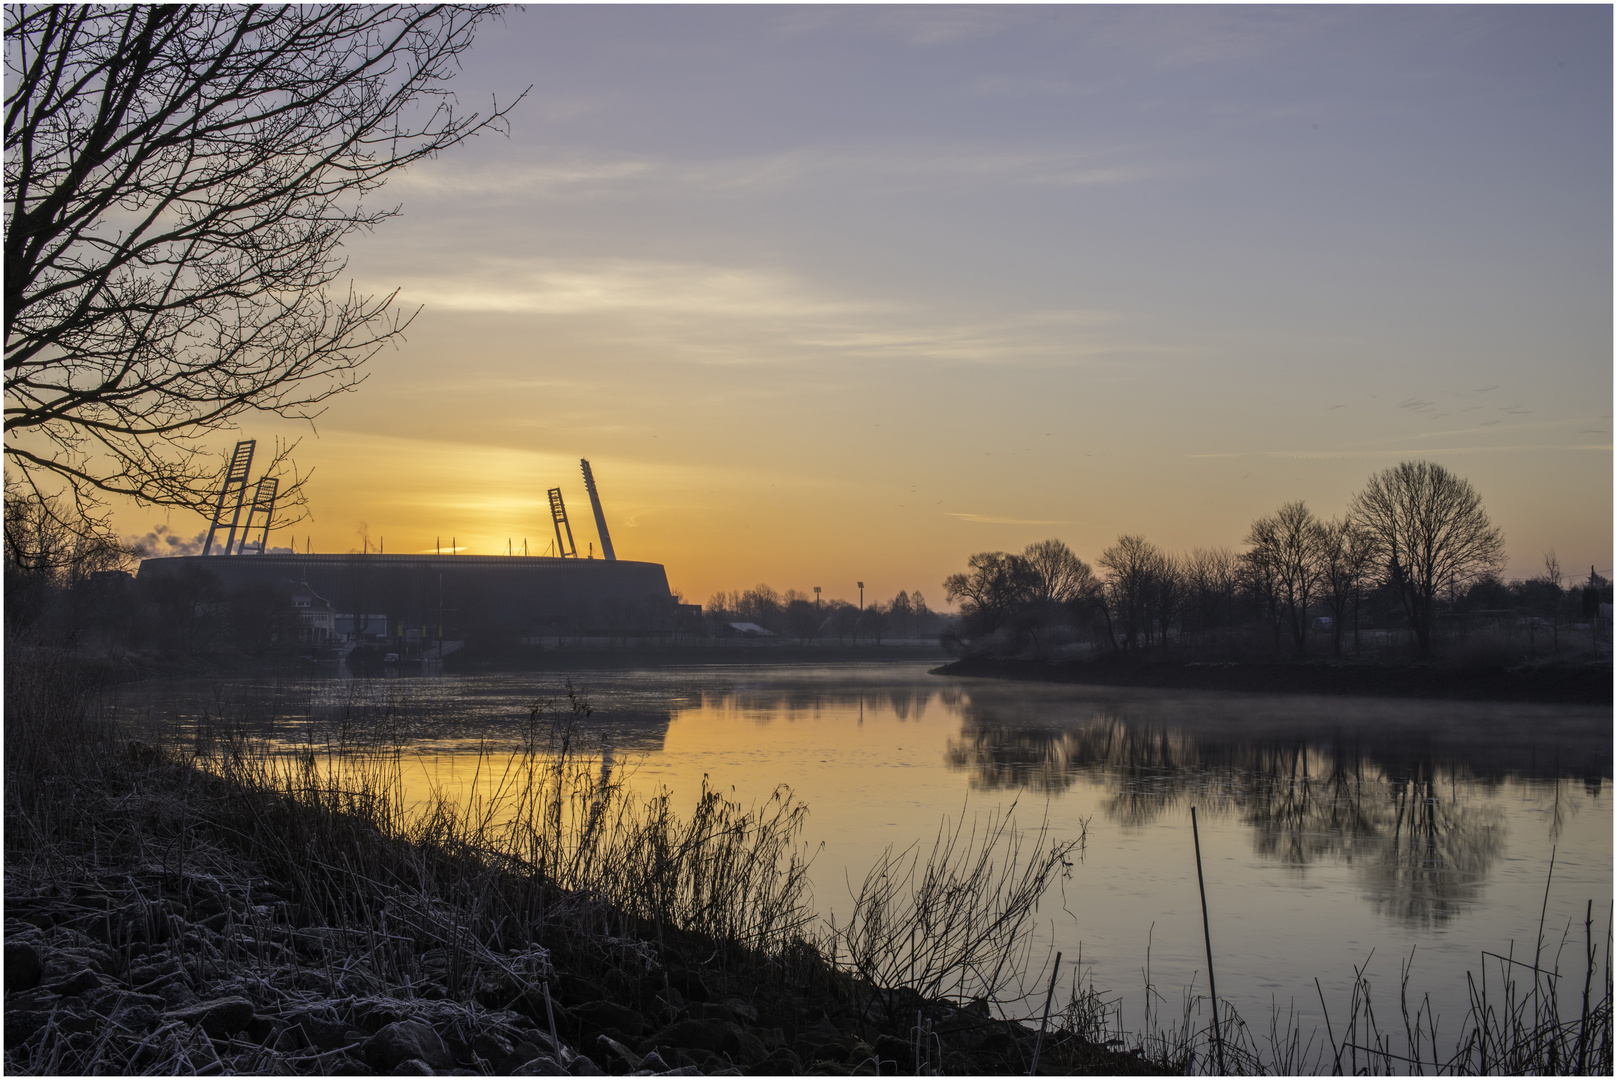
[946,711,1505,923]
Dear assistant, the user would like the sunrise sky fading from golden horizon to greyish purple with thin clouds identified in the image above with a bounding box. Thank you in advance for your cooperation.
[120,5,1612,606]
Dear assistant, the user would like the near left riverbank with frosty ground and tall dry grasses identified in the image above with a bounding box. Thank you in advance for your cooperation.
[5,653,1182,1075]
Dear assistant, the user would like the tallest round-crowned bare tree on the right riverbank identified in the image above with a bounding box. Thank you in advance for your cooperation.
[1349,461,1505,656]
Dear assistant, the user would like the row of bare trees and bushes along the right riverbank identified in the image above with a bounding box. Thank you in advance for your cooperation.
[944,461,1611,658]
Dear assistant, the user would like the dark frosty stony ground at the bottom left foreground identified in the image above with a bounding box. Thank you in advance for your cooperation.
[5,860,1156,1077]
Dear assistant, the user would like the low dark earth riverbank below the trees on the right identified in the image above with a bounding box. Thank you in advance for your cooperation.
[933,656,1612,705]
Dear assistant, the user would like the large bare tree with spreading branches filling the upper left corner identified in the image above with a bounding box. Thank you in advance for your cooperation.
[5,5,509,536]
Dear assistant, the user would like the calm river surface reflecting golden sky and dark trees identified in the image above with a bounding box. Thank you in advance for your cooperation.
[121,664,1612,1033]
